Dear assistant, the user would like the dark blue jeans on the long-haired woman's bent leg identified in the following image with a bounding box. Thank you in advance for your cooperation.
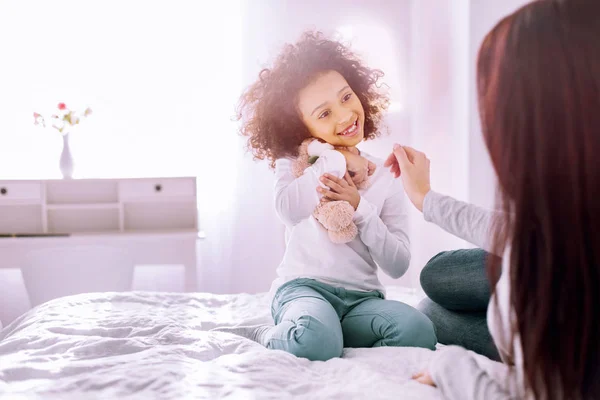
[417,249,500,361]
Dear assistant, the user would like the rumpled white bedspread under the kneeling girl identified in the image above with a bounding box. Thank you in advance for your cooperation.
[0,289,440,399]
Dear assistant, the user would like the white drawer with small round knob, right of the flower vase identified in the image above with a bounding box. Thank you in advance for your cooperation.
[119,178,196,200]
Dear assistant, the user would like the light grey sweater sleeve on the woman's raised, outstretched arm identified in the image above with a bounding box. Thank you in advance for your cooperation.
[423,191,503,256]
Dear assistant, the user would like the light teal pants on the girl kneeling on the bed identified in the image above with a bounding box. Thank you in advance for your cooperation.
[267,279,437,361]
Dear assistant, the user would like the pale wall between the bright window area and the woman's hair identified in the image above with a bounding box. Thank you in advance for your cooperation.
[408,0,527,287]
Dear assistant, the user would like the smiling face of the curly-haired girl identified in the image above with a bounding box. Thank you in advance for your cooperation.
[298,71,365,147]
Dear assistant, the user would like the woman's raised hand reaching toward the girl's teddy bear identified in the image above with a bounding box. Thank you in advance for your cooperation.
[383,144,431,212]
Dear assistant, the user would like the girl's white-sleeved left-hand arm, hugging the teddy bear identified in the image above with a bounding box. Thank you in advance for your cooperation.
[275,150,346,226]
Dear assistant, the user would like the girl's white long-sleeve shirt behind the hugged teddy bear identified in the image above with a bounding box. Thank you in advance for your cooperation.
[271,150,410,294]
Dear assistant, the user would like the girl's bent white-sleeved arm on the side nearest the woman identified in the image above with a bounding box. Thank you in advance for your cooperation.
[354,181,410,279]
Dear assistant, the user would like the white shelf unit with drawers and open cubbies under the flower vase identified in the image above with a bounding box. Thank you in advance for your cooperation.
[0,178,198,235]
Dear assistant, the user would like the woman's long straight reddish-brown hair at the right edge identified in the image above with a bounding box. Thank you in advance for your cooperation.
[477,0,600,399]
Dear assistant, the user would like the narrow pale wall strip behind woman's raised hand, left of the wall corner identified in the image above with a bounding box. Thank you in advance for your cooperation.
[403,0,476,287]
